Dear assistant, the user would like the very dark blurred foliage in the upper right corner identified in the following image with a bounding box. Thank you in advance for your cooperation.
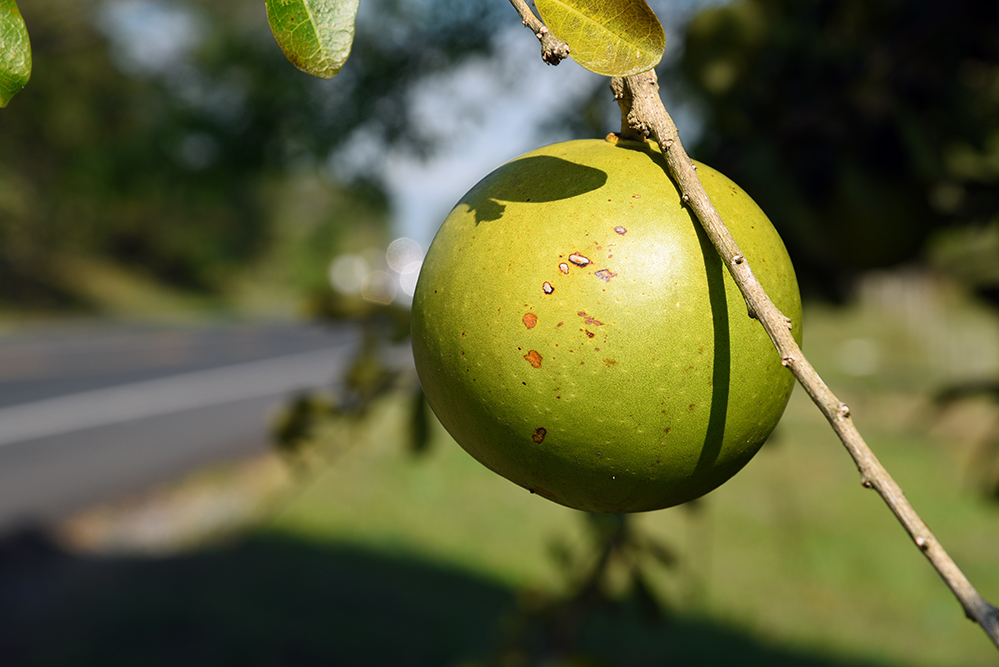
[669,0,999,299]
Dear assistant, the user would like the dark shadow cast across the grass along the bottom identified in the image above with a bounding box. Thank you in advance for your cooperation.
[0,532,900,667]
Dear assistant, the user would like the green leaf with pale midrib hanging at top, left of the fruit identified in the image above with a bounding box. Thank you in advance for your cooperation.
[266,0,359,79]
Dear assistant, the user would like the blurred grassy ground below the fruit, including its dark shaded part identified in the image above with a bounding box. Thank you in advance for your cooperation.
[0,272,999,667]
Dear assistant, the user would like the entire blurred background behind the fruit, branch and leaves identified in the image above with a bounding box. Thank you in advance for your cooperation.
[0,0,999,667]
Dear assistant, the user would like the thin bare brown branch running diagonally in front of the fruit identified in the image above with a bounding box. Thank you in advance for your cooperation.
[611,71,999,648]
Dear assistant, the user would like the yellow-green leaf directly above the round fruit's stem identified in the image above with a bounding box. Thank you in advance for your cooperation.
[534,0,666,76]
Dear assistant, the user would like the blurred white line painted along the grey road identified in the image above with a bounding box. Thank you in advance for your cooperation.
[0,345,351,447]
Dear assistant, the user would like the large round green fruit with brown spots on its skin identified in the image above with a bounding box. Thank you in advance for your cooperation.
[412,137,801,513]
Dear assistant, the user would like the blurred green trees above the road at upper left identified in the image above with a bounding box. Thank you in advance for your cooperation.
[0,0,504,308]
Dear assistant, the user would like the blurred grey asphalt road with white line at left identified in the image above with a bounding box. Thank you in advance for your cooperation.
[0,323,356,533]
